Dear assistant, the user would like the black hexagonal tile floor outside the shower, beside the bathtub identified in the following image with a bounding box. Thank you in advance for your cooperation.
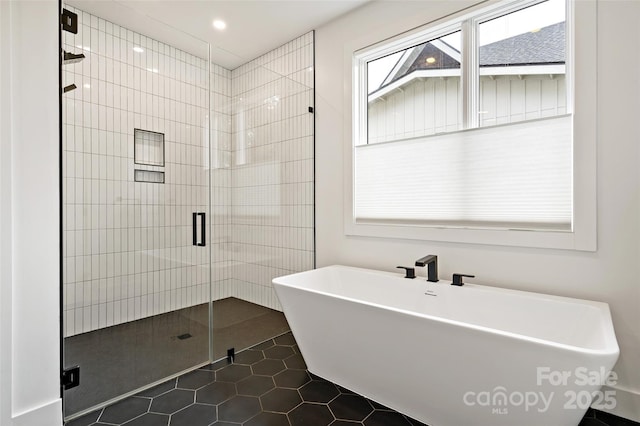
[67,332,640,426]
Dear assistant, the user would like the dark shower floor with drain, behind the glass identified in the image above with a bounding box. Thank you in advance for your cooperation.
[64,298,289,416]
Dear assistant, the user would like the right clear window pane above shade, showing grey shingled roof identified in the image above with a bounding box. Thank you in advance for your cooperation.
[477,0,568,126]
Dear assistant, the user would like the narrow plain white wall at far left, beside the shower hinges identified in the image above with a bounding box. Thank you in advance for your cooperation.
[0,1,62,426]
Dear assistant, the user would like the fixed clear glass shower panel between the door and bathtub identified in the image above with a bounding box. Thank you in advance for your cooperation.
[211,33,314,360]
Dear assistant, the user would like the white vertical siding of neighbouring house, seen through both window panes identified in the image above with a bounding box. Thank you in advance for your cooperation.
[368,75,567,143]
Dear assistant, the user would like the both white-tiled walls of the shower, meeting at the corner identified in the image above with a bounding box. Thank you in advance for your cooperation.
[63,7,314,336]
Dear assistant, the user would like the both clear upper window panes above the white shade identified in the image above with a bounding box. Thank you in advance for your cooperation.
[357,0,568,144]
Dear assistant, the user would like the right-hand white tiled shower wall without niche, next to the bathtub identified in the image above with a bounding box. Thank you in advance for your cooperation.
[229,32,315,310]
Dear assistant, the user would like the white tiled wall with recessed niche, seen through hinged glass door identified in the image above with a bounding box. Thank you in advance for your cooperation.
[63,7,210,336]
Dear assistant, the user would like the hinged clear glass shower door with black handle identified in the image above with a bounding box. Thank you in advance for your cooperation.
[62,6,211,418]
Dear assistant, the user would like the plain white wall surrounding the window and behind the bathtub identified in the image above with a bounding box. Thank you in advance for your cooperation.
[316,0,640,420]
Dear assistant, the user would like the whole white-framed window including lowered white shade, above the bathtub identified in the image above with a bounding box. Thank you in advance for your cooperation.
[345,0,595,250]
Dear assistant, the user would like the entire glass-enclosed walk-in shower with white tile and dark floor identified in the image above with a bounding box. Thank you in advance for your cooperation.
[61,1,315,419]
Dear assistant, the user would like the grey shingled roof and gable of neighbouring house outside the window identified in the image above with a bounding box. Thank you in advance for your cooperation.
[374,22,565,93]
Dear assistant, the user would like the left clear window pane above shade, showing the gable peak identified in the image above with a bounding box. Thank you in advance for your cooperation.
[363,30,462,143]
